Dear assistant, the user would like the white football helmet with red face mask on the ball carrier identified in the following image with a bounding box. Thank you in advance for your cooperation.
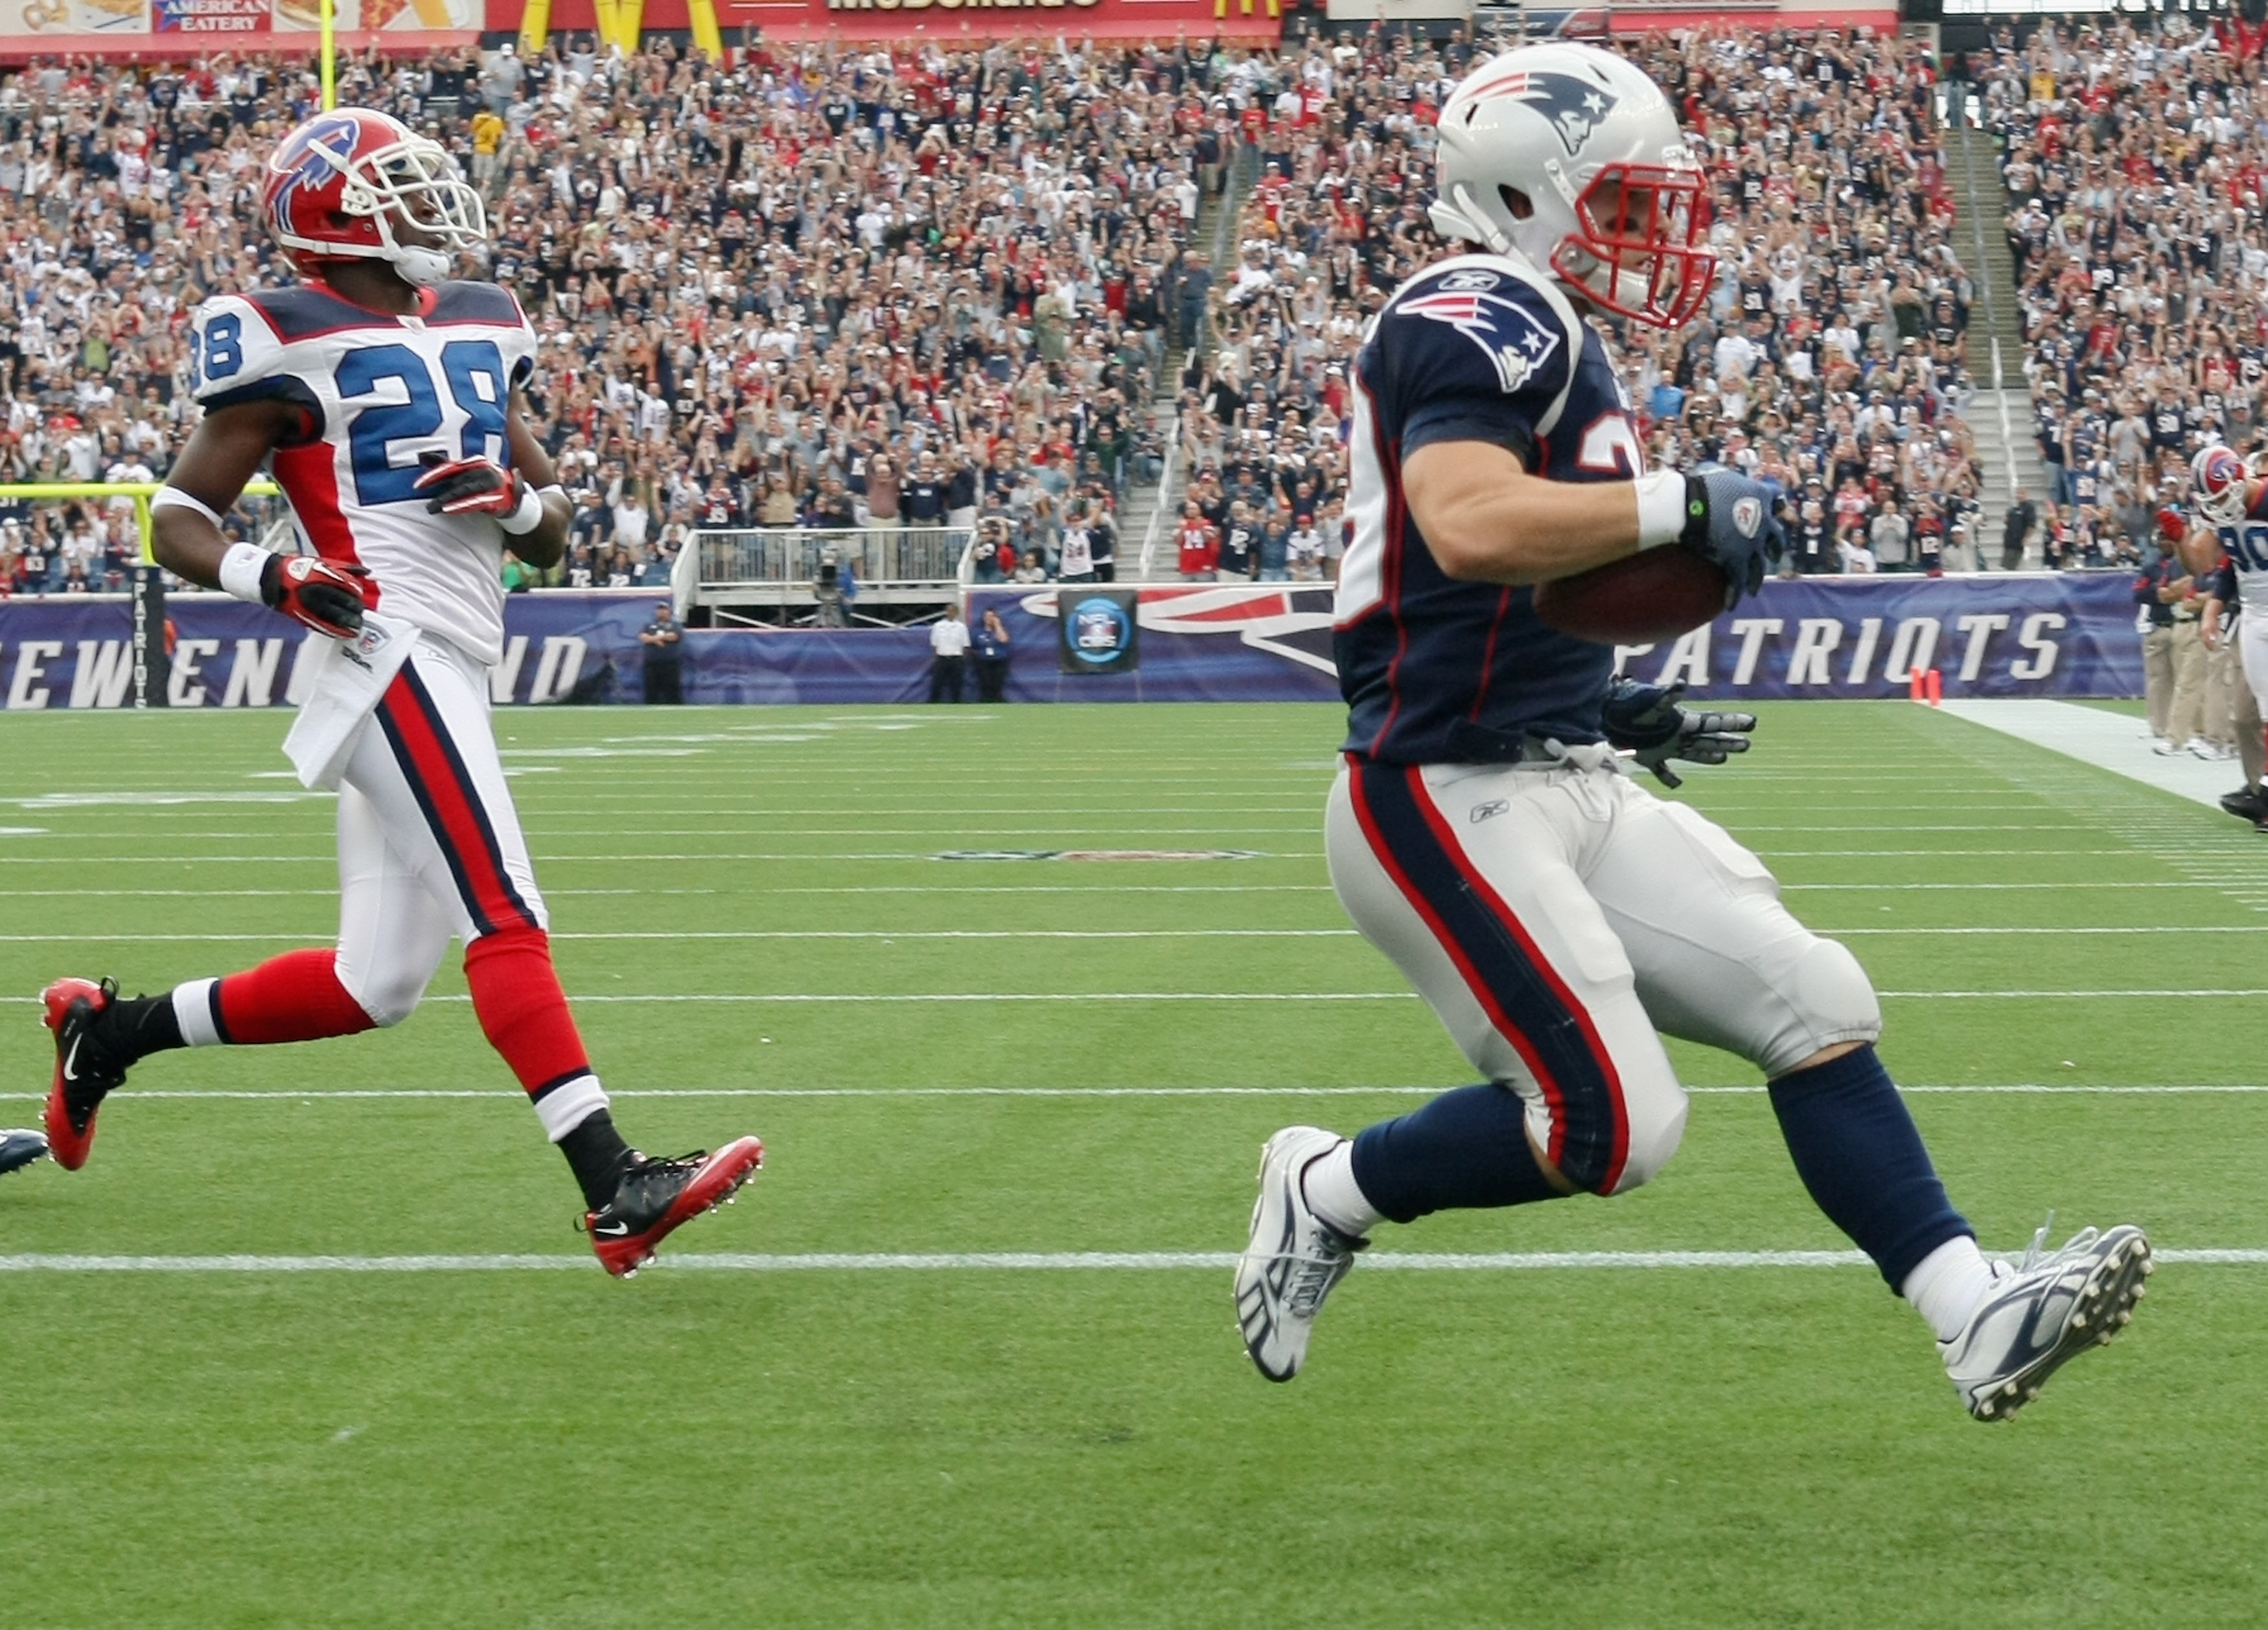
[1431,43,1717,328]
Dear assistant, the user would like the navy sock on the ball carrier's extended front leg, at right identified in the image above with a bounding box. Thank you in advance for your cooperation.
[1769,1048,1976,1290]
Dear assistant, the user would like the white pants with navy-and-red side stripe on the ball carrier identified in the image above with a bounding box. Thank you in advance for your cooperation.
[1325,746,1882,1195]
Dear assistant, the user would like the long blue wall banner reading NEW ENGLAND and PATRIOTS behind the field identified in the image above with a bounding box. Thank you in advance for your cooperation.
[0,571,2141,712]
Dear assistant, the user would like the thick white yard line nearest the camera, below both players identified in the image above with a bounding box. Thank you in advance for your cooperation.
[0,1247,2241,1274]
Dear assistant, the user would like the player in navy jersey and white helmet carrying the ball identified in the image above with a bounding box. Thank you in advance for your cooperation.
[1236,43,2150,1419]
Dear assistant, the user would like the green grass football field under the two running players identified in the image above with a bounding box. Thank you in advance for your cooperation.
[0,703,2268,1630]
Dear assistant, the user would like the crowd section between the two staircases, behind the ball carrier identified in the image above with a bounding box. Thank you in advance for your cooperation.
[1175,29,1978,578]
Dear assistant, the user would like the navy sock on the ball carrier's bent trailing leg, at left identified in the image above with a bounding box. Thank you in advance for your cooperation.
[1354,1084,1560,1222]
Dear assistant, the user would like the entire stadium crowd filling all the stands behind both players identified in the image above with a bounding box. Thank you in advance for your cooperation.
[17,23,2241,591]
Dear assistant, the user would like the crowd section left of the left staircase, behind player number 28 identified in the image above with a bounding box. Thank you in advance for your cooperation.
[0,43,1241,590]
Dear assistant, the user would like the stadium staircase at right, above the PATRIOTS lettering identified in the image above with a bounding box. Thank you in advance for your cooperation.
[1946,97,2048,567]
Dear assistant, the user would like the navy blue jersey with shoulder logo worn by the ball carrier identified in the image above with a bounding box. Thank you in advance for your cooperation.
[1336,254,1640,764]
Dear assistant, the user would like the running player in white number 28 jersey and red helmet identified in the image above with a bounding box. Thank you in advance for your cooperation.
[43,109,762,1276]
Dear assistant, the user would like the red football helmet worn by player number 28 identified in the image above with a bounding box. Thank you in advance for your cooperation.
[263,106,488,288]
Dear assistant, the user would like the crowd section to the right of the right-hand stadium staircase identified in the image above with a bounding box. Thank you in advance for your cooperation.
[1973,14,2268,564]
